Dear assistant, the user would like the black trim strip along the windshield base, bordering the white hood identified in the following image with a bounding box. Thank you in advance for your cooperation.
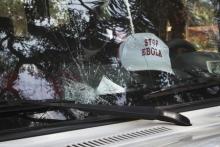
[0,116,131,142]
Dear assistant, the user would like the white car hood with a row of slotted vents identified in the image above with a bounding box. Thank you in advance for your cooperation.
[0,106,220,147]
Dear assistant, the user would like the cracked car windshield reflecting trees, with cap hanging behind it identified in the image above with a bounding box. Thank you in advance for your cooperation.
[0,0,220,131]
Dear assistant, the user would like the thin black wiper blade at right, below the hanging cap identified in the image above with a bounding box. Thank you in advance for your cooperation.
[143,79,220,100]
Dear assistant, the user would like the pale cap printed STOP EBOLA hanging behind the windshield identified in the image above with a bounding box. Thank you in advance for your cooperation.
[119,33,174,74]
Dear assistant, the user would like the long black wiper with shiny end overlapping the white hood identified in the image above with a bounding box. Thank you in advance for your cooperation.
[32,102,191,126]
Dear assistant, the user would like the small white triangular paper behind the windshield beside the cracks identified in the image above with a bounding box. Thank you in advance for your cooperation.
[96,76,126,95]
